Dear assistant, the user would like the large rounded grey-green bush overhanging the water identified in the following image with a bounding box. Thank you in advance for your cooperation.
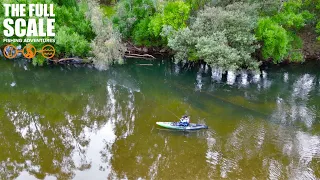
[168,3,259,70]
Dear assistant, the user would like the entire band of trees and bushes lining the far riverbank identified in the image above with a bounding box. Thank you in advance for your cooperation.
[0,0,320,71]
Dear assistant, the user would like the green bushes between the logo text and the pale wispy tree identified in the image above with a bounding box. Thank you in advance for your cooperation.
[55,2,95,57]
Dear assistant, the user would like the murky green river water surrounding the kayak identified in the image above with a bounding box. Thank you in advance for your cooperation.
[0,60,320,180]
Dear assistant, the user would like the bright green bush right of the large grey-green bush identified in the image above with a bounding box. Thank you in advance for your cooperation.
[256,0,314,63]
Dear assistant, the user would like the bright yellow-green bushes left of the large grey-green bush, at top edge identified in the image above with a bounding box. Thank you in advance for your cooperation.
[113,0,190,46]
